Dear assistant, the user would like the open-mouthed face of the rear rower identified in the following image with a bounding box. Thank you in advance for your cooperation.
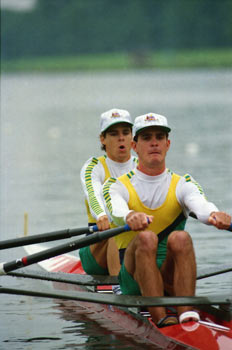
[100,123,132,163]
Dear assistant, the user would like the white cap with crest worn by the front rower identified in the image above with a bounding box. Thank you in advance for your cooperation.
[133,113,171,137]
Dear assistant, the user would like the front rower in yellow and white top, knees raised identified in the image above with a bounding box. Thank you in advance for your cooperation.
[103,113,231,327]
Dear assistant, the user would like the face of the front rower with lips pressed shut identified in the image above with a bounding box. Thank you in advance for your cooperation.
[133,126,170,170]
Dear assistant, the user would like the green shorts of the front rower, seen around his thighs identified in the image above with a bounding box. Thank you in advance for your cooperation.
[118,237,167,295]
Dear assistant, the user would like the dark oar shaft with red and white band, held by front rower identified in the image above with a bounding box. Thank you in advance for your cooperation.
[0,225,130,275]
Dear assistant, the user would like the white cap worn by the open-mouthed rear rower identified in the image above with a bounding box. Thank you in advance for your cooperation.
[100,108,133,132]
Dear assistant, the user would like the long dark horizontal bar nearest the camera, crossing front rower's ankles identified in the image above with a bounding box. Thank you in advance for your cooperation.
[0,287,232,307]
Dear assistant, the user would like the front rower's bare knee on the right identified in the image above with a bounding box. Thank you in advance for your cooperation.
[167,231,193,253]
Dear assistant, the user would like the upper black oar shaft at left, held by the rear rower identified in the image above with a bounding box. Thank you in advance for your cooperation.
[0,225,98,250]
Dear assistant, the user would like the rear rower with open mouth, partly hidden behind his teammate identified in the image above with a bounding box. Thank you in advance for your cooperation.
[80,108,137,276]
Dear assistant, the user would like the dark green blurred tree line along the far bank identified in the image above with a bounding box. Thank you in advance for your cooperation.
[1,0,232,60]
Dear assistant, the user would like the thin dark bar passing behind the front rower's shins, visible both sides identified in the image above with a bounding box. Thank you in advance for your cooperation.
[6,265,232,286]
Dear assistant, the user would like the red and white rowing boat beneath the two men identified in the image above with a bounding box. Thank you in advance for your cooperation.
[22,244,232,350]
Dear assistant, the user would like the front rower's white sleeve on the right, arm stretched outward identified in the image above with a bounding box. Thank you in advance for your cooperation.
[176,176,218,224]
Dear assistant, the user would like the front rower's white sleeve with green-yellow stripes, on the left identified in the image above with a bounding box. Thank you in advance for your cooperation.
[103,180,131,226]
